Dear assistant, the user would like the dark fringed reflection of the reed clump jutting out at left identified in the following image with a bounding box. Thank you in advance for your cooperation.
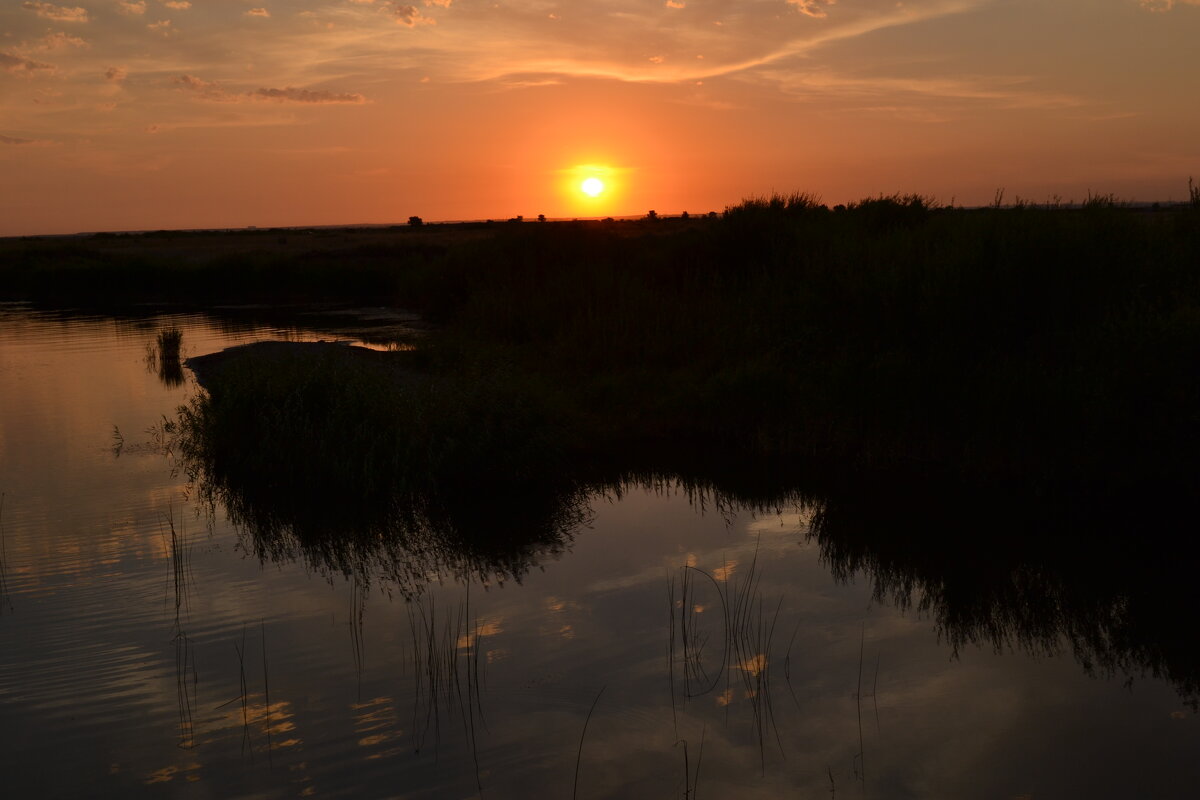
[162,376,589,597]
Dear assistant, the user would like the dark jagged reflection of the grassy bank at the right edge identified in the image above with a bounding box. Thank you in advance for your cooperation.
[812,487,1200,709]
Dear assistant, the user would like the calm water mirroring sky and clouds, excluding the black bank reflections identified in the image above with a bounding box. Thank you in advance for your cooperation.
[0,306,1200,798]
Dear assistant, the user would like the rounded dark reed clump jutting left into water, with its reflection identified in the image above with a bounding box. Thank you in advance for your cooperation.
[160,345,588,597]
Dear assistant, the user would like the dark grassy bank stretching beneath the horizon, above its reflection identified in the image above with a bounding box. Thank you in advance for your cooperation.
[11,196,1200,491]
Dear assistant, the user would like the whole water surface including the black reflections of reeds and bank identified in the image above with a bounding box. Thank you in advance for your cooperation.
[0,304,1200,798]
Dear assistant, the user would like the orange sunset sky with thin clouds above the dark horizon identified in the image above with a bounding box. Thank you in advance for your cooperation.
[0,0,1200,235]
